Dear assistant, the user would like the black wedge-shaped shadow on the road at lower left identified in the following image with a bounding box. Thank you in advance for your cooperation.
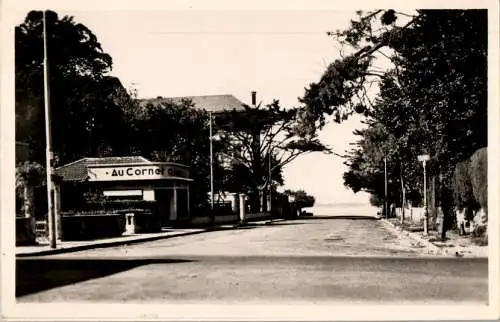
[16,258,193,297]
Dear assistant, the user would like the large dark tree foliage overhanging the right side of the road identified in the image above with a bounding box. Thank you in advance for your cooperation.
[302,10,487,224]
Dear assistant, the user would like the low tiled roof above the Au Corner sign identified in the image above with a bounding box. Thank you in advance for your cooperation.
[56,156,151,182]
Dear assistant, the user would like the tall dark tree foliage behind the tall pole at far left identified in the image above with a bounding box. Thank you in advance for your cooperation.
[15,11,133,164]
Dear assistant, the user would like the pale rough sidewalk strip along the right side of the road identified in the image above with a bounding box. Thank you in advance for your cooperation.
[381,218,488,258]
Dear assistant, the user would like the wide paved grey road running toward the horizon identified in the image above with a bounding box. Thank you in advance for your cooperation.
[17,217,488,303]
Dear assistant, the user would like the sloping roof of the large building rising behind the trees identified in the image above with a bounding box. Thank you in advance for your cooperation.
[139,95,244,113]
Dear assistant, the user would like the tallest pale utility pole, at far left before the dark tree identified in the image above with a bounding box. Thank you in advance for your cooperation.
[43,10,57,248]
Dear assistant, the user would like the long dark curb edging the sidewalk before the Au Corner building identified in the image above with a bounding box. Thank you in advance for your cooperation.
[16,229,209,258]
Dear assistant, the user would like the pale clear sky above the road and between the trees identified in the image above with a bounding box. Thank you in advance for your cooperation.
[11,10,374,204]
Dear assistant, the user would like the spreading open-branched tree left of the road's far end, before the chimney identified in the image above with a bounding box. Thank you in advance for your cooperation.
[215,100,330,210]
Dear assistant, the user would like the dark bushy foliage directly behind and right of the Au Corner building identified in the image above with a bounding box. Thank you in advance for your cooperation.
[130,100,223,211]
